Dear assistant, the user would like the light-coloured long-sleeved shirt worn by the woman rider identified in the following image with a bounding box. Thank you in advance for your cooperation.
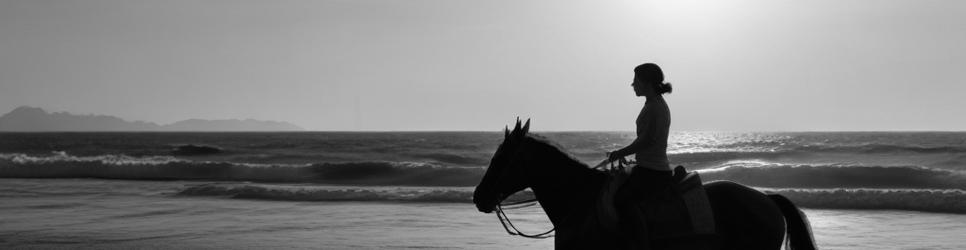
[634,97,671,171]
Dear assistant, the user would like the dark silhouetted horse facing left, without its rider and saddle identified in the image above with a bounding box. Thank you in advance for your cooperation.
[473,119,816,250]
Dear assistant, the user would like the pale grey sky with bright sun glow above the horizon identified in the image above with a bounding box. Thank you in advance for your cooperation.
[0,0,966,131]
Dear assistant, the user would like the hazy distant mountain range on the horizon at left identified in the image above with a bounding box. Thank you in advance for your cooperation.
[0,106,304,132]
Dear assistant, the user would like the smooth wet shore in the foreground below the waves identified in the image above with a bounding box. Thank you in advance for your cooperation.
[0,179,966,249]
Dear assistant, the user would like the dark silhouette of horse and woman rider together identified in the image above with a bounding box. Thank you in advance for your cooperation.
[473,63,816,250]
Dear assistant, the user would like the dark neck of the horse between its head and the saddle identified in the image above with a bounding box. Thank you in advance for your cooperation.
[530,140,603,225]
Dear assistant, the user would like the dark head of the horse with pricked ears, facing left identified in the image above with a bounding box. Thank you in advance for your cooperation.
[473,119,530,213]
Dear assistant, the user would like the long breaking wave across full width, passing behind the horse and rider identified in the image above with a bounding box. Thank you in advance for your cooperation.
[0,152,966,190]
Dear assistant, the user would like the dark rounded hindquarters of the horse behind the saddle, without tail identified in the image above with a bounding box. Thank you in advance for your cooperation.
[704,181,785,249]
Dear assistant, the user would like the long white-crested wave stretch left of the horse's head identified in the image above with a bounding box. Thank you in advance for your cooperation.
[0,153,483,186]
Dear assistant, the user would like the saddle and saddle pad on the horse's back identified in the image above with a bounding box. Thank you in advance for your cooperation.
[601,166,717,249]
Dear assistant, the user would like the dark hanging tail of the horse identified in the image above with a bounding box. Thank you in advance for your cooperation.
[768,194,818,250]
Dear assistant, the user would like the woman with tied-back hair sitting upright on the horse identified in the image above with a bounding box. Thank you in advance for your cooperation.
[607,63,673,249]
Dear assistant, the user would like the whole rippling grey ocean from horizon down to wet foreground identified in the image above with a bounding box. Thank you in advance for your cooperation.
[0,131,966,249]
